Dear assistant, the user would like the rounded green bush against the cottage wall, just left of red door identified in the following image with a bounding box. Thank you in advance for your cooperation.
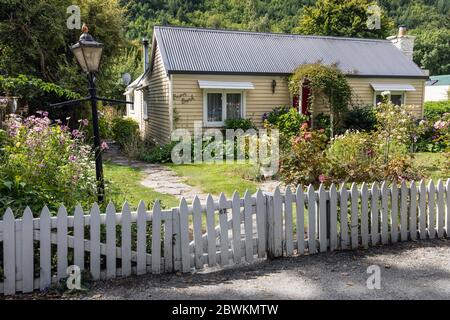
[263,106,308,139]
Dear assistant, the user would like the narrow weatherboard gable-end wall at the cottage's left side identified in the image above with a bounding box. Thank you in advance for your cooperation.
[147,48,170,143]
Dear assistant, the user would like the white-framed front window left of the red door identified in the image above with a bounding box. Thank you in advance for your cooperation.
[203,91,244,127]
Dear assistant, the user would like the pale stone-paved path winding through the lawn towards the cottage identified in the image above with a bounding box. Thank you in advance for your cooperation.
[103,143,279,203]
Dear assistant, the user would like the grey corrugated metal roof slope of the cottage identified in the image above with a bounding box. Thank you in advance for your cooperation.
[154,26,426,78]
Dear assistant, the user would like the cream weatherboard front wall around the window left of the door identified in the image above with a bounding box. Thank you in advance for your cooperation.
[173,74,290,131]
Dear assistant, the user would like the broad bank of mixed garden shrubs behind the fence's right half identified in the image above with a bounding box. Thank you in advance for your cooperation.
[280,102,426,185]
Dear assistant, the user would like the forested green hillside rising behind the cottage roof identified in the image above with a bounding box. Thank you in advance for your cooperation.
[120,0,450,74]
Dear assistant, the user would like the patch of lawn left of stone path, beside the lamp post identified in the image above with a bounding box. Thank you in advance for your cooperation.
[104,162,179,210]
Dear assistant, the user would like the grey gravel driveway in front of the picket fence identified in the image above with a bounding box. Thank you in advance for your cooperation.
[70,240,450,300]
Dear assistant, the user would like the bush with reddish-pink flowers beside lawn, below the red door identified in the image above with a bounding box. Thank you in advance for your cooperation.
[280,122,328,186]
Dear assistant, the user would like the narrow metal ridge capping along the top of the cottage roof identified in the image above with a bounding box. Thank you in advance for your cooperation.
[154,25,390,42]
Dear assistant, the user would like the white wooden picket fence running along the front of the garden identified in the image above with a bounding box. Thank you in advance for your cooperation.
[0,179,450,295]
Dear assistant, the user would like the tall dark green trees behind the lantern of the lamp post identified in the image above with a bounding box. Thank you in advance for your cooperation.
[0,0,130,102]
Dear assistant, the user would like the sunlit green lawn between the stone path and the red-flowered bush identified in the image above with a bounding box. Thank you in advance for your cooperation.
[167,163,257,197]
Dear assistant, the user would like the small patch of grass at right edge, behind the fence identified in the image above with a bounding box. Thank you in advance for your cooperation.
[414,152,450,181]
